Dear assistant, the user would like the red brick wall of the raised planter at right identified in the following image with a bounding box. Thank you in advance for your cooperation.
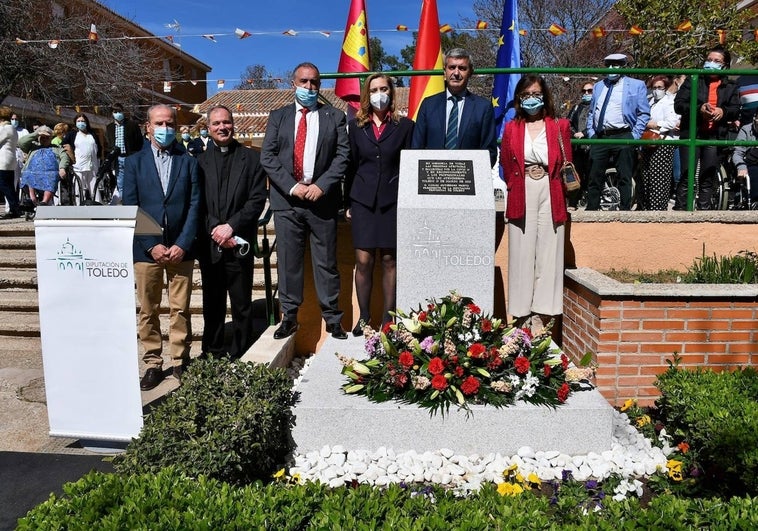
[562,276,758,406]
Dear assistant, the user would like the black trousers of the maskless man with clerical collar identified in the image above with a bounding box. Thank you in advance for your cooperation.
[200,250,253,358]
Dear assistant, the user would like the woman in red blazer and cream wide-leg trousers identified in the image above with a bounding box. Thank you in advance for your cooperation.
[500,74,571,324]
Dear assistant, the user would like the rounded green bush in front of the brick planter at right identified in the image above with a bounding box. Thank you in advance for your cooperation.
[656,361,758,496]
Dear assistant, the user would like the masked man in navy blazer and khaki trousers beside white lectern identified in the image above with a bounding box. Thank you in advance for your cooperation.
[122,105,200,391]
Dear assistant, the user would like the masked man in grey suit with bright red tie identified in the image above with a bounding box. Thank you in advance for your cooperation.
[261,63,350,339]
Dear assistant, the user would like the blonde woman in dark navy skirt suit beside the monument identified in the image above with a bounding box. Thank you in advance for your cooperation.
[345,74,413,336]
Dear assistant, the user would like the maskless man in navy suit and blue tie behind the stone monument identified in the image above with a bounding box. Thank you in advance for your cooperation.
[412,48,497,166]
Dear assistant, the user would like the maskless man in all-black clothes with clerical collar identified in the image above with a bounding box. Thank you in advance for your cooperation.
[197,105,266,358]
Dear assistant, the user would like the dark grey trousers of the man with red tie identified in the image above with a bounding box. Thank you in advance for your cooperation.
[274,207,342,325]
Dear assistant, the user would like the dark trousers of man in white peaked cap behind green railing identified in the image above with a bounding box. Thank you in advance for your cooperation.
[587,132,636,210]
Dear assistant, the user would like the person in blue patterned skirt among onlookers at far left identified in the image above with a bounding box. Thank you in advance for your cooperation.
[18,125,70,206]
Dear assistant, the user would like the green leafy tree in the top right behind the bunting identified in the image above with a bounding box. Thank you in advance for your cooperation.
[616,0,758,68]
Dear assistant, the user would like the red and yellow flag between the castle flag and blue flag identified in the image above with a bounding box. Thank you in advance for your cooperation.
[408,0,445,120]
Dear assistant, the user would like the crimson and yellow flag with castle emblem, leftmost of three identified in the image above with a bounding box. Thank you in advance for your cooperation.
[334,0,371,110]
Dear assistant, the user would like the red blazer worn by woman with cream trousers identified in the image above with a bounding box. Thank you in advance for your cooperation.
[500,118,571,223]
